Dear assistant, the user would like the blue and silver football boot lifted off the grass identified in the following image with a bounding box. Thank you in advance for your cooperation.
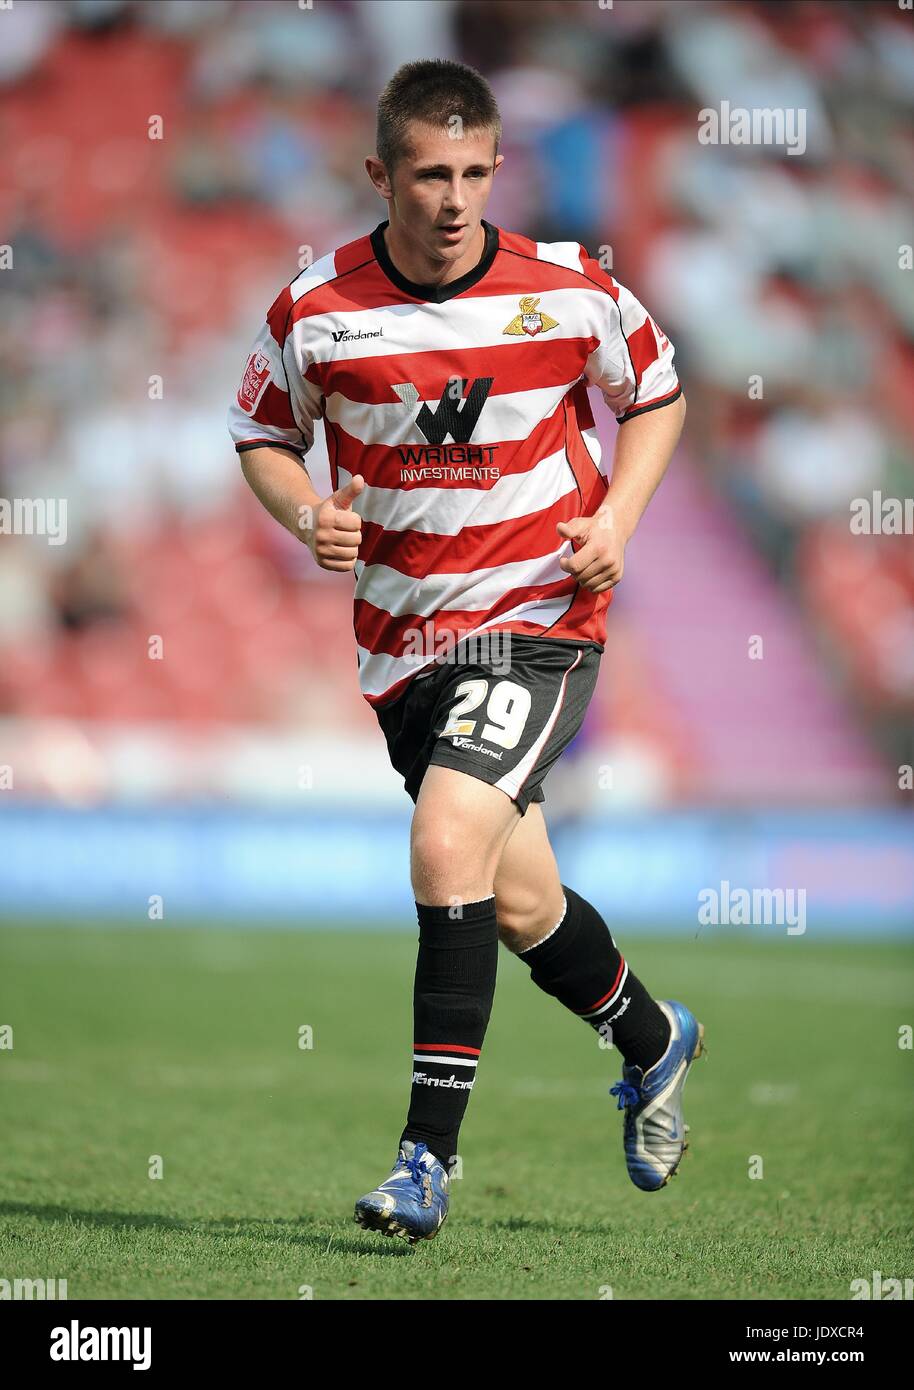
[610,999,704,1193]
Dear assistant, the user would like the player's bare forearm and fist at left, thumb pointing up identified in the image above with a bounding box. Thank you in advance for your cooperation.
[240,445,365,571]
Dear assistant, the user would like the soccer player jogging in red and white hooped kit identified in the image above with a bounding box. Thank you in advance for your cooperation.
[229,60,703,1243]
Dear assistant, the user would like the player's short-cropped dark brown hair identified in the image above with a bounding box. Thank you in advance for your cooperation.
[378,58,501,174]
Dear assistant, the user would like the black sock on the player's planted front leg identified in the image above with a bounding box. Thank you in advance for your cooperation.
[400,895,499,1168]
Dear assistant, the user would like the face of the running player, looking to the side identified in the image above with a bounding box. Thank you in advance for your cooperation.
[389,122,503,263]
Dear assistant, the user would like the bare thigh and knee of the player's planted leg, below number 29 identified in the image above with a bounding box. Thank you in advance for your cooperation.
[410,763,518,902]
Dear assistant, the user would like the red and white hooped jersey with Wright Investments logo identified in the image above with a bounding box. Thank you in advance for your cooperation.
[229,222,681,706]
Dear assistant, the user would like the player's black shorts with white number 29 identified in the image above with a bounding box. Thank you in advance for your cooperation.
[375,634,603,815]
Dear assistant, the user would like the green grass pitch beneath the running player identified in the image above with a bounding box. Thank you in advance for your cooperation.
[0,923,914,1300]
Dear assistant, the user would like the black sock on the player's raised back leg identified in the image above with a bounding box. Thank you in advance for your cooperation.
[518,884,670,1072]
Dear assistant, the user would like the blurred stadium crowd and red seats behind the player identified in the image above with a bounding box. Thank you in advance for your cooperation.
[0,0,914,801]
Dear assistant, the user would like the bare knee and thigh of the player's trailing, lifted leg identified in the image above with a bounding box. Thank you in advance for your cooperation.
[495,803,564,951]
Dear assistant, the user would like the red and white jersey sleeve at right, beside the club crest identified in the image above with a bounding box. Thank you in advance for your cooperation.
[582,253,682,424]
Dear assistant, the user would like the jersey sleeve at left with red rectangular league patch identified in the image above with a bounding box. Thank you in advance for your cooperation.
[228,289,324,457]
